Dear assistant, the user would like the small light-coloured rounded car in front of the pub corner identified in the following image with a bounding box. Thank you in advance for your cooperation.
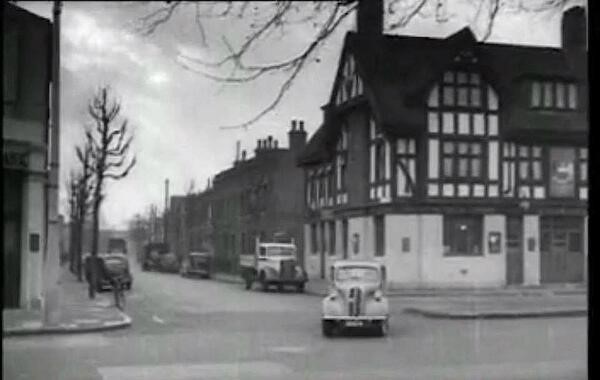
[321,260,389,337]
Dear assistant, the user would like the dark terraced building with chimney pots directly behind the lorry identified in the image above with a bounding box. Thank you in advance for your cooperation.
[210,120,306,273]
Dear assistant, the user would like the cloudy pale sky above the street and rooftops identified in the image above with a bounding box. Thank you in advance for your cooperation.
[17,0,583,228]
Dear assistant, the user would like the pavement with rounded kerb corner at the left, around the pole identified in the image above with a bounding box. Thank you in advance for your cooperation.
[2,267,131,337]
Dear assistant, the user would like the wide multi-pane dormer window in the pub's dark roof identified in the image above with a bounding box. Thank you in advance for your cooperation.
[530,81,577,110]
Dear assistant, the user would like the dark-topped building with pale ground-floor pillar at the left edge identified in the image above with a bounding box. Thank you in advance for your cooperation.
[2,4,52,309]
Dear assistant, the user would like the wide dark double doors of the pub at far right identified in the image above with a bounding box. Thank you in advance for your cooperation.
[540,216,584,284]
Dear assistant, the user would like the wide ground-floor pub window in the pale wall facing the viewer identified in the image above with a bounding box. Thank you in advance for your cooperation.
[443,215,483,256]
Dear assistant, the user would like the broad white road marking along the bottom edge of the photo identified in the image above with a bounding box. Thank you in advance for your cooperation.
[98,361,292,380]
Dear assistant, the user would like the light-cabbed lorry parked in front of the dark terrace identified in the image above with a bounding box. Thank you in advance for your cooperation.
[240,238,308,293]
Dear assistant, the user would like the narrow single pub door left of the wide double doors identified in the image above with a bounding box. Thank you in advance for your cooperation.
[506,216,523,285]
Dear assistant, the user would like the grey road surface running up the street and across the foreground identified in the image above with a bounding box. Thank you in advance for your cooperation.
[2,266,587,380]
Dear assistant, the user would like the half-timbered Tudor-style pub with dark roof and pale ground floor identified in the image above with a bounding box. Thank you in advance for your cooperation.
[298,0,589,287]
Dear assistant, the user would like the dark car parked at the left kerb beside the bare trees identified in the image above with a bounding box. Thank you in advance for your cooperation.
[85,254,133,292]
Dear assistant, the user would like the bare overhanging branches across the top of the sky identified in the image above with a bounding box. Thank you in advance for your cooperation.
[136,0,578,129]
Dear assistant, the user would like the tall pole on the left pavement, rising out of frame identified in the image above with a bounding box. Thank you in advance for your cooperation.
[43,0,62,325]
